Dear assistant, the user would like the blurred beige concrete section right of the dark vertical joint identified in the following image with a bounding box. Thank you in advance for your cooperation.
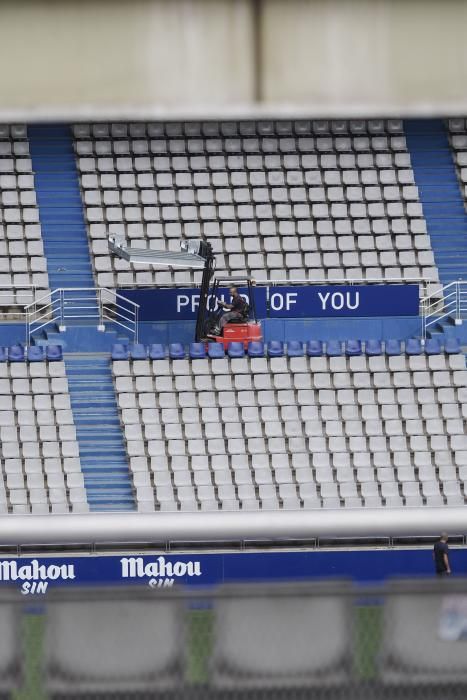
[261,0,467,113]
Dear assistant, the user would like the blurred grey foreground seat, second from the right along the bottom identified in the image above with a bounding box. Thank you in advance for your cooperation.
[212,593,347,690]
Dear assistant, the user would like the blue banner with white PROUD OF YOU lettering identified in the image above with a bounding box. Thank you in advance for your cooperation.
[119,284,419,322]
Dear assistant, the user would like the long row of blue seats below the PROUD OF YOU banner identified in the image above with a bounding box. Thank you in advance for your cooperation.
[112,337,461,361]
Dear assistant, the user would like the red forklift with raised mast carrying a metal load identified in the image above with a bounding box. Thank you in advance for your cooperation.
[109,236,263,348]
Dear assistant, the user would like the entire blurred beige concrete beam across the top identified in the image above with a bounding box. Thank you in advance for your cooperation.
[0,0,467,119]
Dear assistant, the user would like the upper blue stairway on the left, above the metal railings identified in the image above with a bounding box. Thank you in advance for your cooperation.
[28,124,95,289]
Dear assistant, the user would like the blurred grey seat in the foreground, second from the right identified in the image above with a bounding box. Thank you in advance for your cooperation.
[211,586,350,692]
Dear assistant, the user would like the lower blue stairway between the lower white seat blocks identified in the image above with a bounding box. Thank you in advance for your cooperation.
[65,353,135,511]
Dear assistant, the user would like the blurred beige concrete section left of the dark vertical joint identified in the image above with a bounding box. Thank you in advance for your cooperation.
[0,0,254,116]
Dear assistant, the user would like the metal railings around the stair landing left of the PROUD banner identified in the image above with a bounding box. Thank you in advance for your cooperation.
[24,287,139,345]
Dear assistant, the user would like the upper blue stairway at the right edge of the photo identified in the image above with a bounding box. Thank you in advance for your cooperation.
[404,119,467,284]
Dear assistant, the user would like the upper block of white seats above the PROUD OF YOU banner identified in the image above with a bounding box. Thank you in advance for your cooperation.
[74,120,439,287]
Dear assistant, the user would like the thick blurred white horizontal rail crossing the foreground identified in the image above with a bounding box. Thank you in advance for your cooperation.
[0,506,467,547]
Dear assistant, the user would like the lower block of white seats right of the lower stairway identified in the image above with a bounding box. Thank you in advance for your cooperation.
[113,353,467,511]
